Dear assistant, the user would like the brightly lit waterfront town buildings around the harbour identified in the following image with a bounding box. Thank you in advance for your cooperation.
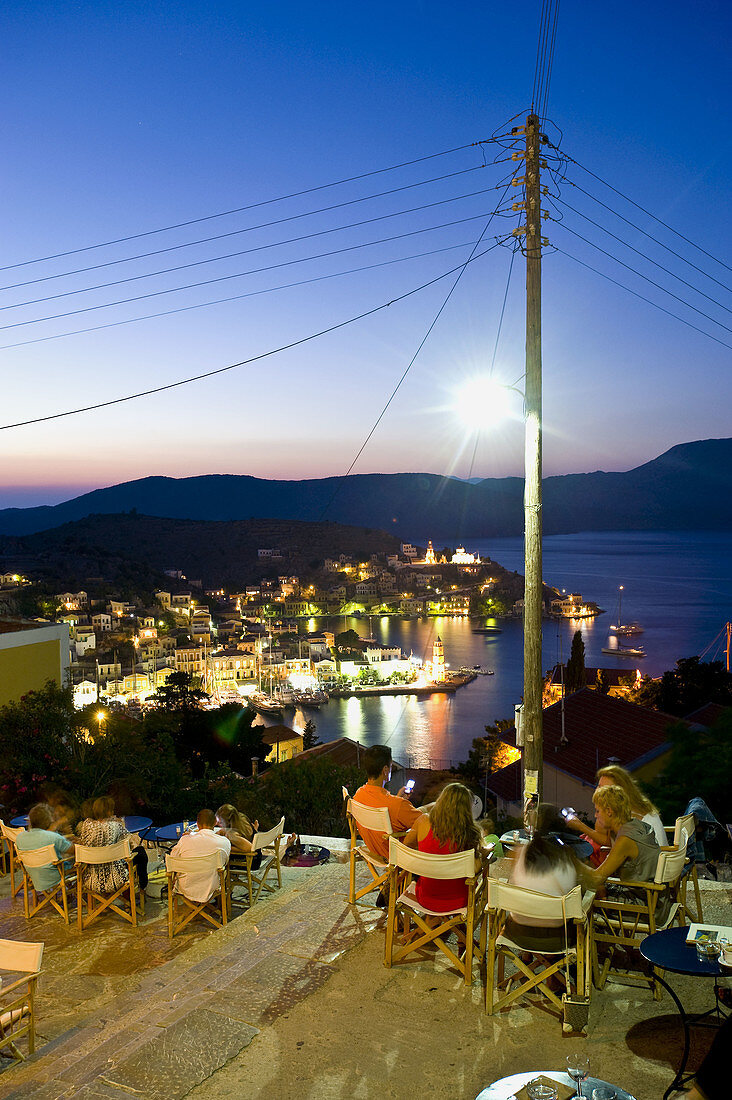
[0,534,600,706]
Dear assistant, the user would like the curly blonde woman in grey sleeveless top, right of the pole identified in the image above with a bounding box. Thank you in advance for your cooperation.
[592,787,671,924]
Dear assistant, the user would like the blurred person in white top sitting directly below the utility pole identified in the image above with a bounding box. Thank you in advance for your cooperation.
[504,803,582,954]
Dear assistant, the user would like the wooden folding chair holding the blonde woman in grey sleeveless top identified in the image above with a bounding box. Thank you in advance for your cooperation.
[592,844,686,1001]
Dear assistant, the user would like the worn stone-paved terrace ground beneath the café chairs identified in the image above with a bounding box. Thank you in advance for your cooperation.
[0,862,732,1100]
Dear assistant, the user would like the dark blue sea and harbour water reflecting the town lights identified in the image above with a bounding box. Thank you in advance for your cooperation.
[255,531,732,768]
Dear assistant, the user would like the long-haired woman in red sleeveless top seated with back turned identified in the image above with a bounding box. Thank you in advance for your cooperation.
[404,783,481,913]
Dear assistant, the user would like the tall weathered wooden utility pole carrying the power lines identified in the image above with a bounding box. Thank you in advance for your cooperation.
[520,113,544,813]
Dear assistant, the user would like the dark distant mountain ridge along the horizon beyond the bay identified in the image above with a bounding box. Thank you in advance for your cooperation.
[0,439,732,539]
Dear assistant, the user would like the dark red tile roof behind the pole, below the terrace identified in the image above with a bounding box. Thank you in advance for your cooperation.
[488,688,684,801]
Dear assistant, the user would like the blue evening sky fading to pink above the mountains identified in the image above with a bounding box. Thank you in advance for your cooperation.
[0,0,732,507]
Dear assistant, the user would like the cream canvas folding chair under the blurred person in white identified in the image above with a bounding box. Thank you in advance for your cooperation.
[485,879,594,1015]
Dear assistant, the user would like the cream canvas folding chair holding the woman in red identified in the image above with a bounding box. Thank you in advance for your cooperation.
[384,836,488,986]
